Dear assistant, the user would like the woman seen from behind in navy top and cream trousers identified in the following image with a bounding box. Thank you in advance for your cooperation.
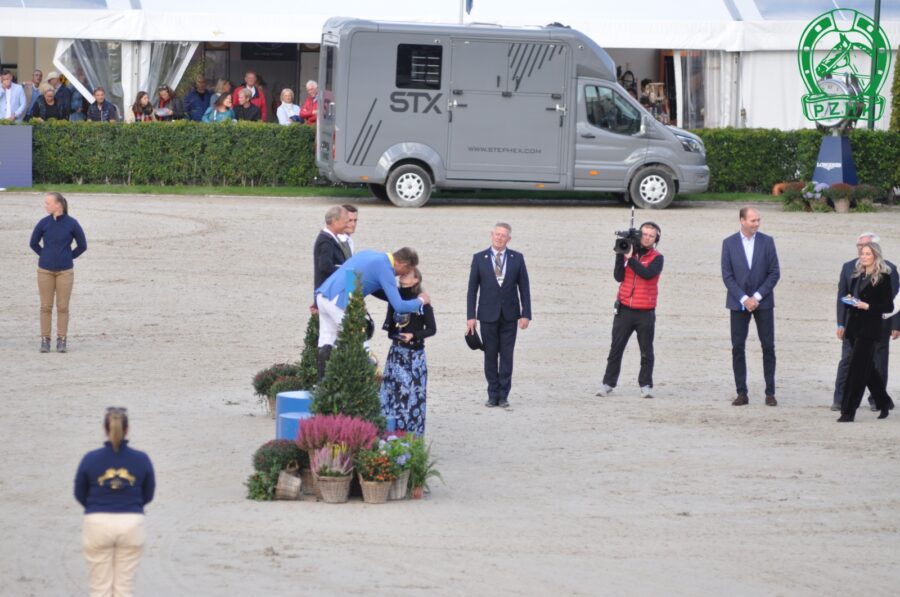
[75,408,156,597]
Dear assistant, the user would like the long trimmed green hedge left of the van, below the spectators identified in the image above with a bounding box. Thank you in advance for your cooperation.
[22,121,317,186]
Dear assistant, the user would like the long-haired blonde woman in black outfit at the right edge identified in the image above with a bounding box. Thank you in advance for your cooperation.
[838,242,894,423]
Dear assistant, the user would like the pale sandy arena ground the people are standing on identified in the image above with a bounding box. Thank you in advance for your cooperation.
[0,193,900,596]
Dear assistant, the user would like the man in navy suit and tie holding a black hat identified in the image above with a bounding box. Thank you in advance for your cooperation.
[466,222,531,408]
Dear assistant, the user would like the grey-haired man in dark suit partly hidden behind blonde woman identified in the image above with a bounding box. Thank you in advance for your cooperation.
[831,232,900,411]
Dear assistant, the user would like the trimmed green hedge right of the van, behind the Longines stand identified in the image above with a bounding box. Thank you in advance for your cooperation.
[694,128,900,193]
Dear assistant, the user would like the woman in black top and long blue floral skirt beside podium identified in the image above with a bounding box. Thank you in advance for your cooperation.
[381,268,437,436]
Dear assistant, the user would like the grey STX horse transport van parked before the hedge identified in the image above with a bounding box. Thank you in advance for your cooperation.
[316,18,709,209]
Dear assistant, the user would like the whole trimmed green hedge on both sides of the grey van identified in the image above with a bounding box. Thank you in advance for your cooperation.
[3,121,900,193]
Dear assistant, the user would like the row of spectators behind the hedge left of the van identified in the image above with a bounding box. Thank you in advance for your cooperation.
[0,69,319,126]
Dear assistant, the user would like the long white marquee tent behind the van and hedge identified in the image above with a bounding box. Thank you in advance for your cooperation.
[0,0,900,129]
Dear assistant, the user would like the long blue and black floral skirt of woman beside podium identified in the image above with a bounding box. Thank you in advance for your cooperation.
[381,345,428,436]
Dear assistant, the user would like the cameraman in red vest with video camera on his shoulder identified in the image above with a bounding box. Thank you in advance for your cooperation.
[597,222,663,398]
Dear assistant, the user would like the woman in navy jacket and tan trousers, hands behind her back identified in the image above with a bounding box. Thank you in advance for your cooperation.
[31,193,87,352]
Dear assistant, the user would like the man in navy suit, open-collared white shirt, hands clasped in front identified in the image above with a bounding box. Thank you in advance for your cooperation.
[722,207,781,406]
